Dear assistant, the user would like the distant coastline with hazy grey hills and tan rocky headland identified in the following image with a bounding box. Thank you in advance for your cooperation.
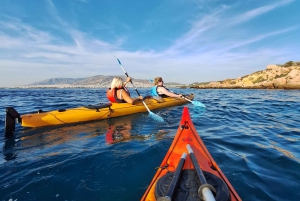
[0,61,300,89]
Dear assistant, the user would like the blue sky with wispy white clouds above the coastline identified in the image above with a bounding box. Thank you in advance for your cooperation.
[0,0,300,87]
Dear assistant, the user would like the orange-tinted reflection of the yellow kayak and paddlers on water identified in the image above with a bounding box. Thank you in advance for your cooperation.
[3,110,169,164]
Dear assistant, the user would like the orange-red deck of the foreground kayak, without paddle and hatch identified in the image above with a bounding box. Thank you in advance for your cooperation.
[141,107,241,201]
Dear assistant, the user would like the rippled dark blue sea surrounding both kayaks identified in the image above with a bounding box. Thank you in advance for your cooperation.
[0,89,300,201]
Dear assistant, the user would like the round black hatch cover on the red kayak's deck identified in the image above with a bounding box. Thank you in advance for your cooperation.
[155,169,231,201]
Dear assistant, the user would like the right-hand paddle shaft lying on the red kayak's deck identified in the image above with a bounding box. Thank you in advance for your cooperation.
[186,144,216,201]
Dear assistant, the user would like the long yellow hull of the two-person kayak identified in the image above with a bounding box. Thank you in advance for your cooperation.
[21,94,194,127]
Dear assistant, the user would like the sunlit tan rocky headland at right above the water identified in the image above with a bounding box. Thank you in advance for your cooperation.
[190,61,300,89]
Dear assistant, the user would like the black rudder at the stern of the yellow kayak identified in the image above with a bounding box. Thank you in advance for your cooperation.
[5,107,21,137]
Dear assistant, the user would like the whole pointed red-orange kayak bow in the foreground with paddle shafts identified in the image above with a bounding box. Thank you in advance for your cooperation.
[141,107,242,201]
